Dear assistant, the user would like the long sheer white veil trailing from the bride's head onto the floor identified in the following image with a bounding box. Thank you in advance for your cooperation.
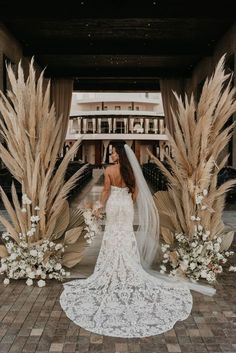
[124,144,216,296]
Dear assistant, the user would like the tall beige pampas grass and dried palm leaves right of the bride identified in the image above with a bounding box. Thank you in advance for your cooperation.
[147,55,236,248]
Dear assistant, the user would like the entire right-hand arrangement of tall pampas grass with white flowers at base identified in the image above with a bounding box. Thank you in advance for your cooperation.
[147,55,236,283]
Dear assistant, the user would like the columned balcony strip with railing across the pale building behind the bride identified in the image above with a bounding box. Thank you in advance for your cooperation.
[68,116,165,135]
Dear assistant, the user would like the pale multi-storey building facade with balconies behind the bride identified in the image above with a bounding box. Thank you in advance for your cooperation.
[66,92,169,167]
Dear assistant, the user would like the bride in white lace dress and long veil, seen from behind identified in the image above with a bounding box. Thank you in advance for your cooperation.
[60,141,215,337]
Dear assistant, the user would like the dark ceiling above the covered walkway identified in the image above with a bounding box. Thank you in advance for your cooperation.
[0,0,235,90]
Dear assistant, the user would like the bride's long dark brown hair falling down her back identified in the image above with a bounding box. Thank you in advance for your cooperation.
[112,140,135,193]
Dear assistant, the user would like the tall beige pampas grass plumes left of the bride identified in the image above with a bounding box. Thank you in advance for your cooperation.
[0,59,88,265]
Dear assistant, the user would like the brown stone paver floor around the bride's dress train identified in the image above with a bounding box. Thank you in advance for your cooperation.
[0,172,236,353]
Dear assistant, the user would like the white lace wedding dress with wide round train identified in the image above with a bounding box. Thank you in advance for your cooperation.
[60,186,192,337]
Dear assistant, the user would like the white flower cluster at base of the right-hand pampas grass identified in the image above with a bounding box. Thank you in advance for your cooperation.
[160,189,236,283]
